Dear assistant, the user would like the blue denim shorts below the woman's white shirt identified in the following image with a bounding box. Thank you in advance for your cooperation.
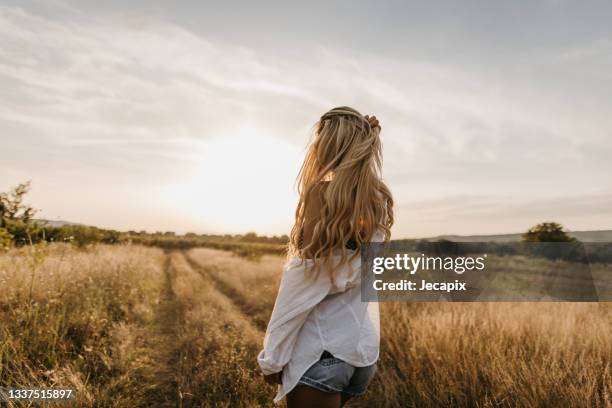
[298,352,376,397]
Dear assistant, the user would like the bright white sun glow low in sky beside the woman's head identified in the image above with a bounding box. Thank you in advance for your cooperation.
[168,125,303,234]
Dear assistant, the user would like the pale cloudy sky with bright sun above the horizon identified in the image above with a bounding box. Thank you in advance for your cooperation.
[0,0,612,238]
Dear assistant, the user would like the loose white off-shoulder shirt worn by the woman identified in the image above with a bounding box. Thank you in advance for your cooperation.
[257,232,383,403]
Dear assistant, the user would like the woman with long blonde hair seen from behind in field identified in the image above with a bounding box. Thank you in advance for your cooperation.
[258,106,393,408]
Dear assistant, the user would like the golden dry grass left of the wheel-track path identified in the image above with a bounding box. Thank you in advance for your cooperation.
[0,244,163,406]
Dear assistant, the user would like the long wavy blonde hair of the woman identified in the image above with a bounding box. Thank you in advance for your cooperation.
[288,106,393,281]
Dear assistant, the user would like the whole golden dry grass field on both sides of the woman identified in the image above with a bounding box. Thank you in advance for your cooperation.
[0,244,612,407]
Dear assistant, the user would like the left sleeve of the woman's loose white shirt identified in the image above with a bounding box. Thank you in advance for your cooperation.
[257,267,331,375]
